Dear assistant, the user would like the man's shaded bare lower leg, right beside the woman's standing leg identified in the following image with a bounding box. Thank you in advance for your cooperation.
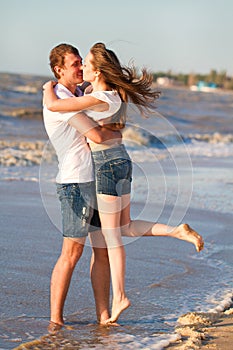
[89,231,110,324]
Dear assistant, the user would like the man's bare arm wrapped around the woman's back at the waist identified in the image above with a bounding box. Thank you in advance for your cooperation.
[68,113,122,144]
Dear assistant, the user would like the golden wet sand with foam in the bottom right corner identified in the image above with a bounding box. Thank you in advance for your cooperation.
[166,305,233,350]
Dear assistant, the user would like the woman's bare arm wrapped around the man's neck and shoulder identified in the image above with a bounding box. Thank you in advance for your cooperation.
[43,81,108,112]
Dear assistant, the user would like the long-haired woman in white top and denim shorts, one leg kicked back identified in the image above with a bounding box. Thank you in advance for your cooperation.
[44,43,203,323]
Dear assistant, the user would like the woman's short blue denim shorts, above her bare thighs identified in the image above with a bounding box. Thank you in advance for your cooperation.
[92,145,132,197]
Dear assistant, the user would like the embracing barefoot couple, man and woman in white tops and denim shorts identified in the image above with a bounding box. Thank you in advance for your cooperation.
[43,43,204,331]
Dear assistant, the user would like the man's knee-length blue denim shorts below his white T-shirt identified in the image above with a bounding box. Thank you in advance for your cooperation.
[57,181,100,238]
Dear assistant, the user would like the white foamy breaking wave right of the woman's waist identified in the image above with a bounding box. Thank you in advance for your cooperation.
[123,127,233,162]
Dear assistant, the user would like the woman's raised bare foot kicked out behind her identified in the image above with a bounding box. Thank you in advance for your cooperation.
[172,224,204,252]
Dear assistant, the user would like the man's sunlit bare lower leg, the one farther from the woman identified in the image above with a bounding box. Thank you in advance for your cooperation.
[50,238,85,325]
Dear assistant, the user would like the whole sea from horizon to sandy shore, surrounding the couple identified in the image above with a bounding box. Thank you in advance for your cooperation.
[0,73,233,350]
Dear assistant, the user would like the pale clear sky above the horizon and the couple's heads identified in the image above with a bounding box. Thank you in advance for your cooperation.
[0,0,233,76]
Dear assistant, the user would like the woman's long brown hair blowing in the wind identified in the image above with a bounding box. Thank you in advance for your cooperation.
[90,43,160,128]
